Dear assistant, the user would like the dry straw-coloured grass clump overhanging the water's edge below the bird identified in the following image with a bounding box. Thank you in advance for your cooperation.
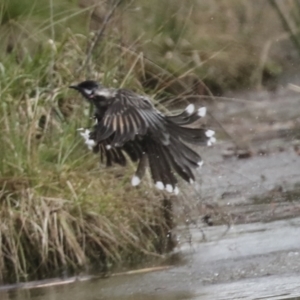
[0,172,169,281]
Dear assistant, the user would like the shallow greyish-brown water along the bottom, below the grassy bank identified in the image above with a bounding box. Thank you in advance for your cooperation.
[0,218,300,300]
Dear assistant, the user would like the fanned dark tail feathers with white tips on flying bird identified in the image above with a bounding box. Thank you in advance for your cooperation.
[132,104,216,194]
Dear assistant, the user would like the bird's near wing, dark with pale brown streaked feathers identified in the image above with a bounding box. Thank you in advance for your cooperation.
[96,89,169,147]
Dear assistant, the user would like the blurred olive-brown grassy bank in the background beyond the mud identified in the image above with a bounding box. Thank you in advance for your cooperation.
[122,0,283,94]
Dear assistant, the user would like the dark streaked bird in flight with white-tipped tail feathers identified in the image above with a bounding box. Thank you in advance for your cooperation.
[70,80,216,194]
